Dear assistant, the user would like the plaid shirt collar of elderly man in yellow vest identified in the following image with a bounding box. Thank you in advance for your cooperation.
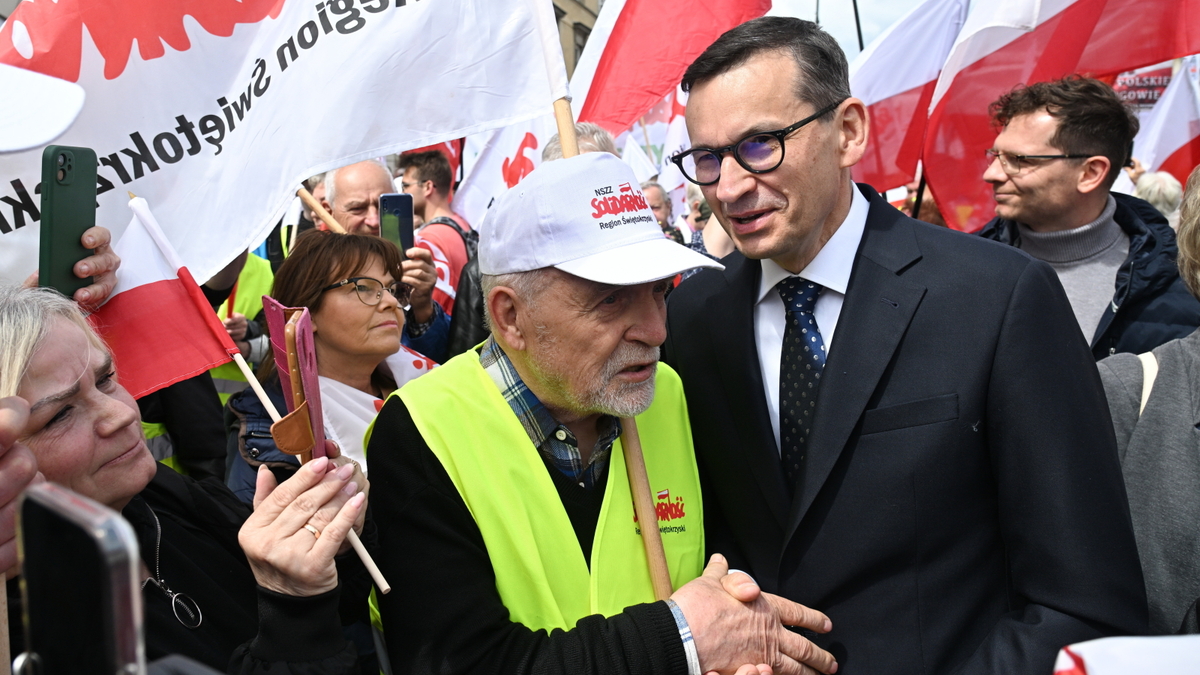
[479,336,620,488]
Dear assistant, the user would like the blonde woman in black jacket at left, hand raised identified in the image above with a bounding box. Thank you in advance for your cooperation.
[0,281,370,674]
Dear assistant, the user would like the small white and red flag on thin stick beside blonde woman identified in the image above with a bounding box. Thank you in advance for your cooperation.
[89,197,238,399]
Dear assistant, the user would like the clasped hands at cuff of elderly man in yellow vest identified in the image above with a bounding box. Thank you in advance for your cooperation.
[671,555,838,675]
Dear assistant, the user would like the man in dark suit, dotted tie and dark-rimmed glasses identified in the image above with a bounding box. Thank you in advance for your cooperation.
[665,18,1147,675]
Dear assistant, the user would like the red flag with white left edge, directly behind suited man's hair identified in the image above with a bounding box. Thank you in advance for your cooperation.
[571,0,770,136]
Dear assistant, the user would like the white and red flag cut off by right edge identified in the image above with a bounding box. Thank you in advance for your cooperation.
[1133,56,1200,184]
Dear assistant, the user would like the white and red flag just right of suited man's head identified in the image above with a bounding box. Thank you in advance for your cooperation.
[850,0,968,192]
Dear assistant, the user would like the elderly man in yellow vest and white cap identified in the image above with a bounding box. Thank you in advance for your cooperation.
[367,153,836,675]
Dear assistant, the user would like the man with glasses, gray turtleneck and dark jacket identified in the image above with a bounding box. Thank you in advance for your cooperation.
[980,76,1200,359]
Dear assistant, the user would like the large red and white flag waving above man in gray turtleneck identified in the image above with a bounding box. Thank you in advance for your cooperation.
[923,0,1200,232]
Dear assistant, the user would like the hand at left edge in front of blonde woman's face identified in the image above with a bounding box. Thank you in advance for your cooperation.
[0,396,44,579]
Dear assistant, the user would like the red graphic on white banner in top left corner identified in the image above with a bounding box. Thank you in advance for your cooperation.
[0,0,284,82]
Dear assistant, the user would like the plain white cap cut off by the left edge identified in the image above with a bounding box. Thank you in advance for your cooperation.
[0,64,84,153]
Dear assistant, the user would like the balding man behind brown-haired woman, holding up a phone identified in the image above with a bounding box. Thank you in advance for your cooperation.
[320,160,450,363]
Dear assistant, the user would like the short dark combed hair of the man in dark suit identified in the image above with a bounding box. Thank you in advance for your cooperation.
[683,17,850,118]
